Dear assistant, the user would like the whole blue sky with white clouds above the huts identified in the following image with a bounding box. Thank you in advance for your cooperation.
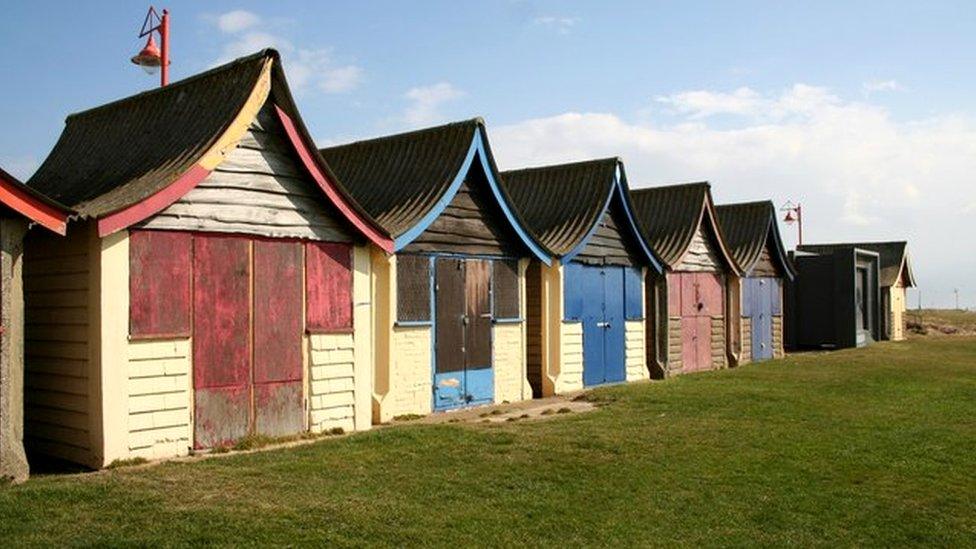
[0,1,976,307]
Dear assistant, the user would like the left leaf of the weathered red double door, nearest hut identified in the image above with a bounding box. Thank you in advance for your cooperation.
[193,236,251,448]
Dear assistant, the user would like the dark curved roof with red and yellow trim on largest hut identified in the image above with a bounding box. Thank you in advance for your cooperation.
[27,49,392,249]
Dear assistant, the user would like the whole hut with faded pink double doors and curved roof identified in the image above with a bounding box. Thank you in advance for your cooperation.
[630,183,740,376]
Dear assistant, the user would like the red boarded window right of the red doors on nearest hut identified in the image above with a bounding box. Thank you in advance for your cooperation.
[305,242,352,333]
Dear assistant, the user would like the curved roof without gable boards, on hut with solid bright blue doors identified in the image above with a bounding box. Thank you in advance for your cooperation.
[501,158,660,270]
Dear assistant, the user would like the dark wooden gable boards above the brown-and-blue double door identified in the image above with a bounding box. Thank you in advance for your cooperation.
[403,171,524,256]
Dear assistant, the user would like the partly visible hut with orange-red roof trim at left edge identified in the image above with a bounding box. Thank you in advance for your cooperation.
[0,169,68,484]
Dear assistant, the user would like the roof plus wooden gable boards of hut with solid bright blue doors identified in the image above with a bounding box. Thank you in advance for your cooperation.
[502,158,658,270]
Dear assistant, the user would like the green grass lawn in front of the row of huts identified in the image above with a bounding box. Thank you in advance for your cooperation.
[0,338,976,547]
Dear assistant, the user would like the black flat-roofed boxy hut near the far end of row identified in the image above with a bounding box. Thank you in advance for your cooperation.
[786,244,881,349]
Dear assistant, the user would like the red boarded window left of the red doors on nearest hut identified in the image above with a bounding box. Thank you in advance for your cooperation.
[129,231,192,338]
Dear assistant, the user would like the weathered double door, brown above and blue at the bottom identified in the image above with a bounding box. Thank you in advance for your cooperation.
[434,258,495,410]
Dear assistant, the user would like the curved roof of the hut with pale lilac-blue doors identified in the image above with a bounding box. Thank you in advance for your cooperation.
[715,200,794,280]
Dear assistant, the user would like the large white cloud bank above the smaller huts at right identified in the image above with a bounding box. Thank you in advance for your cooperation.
[491,84,976,304]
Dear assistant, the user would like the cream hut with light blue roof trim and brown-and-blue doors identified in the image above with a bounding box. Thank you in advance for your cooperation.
[321,119,549,422]
